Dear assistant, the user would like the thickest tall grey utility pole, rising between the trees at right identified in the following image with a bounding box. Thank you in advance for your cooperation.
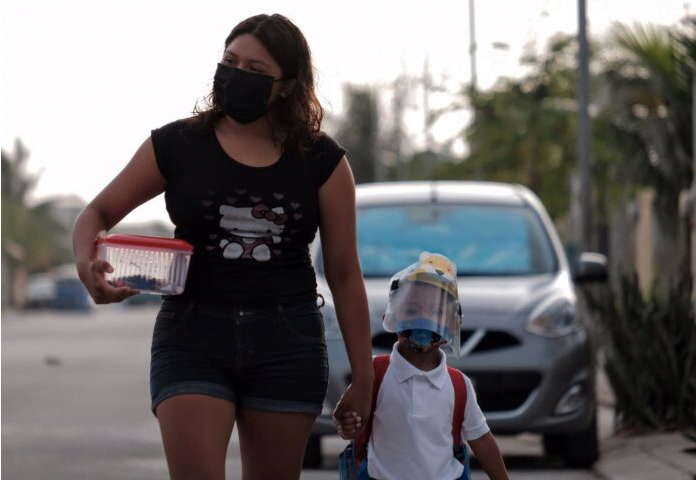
[576,0,592,251]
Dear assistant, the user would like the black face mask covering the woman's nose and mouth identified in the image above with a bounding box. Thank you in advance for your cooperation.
[213,63,275,123]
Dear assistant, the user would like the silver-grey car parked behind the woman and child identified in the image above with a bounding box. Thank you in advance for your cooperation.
[305,182,607,467]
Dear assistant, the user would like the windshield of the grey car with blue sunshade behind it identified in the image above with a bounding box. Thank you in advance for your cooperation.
[350,204,557,277]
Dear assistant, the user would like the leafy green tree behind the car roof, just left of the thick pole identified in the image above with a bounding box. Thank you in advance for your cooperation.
[452,34,577,217]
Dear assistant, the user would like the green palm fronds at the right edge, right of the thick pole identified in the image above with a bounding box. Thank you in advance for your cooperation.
[602,16,696,233]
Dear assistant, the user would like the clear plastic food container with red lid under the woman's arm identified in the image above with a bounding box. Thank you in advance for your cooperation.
[97,234,193,295]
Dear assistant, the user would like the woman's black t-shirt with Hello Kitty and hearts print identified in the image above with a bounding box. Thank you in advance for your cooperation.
[152,120,346,305]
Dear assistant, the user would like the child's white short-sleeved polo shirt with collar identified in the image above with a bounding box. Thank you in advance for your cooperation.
[367,344,489,480]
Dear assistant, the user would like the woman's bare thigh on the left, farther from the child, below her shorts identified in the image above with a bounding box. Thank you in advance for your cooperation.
[157,394,235,480]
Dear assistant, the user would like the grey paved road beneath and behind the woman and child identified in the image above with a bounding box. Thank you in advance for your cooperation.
[2,305,596,480]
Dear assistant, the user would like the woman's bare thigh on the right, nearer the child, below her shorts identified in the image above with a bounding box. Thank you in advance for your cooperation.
[237,408,316,480]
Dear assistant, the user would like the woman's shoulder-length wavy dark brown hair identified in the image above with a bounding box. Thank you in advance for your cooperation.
[192,14,324,155]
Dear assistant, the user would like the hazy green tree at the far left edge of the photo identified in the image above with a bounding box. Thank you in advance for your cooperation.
[1,139,72,271]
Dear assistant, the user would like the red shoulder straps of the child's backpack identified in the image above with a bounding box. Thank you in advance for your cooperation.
[355,355,467,466]
